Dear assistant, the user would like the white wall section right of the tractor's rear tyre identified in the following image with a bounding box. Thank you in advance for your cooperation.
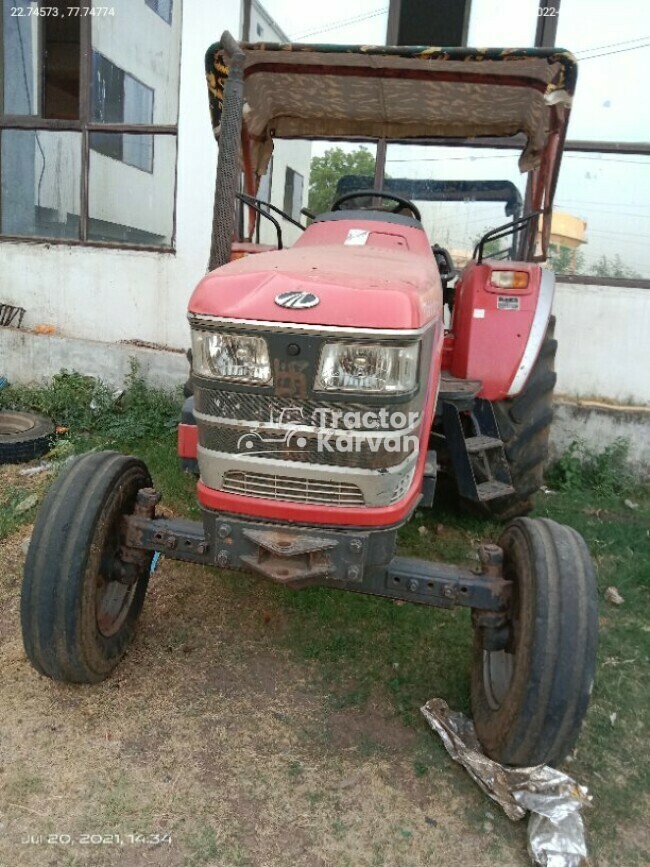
[553,283,650,406]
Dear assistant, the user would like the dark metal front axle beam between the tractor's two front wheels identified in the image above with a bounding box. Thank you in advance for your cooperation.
[115,488,511,650]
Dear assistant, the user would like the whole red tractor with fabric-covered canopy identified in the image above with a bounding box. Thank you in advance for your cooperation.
[22,33,597,765]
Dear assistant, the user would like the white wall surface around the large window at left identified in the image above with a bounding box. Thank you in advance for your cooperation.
[0,0,241,352]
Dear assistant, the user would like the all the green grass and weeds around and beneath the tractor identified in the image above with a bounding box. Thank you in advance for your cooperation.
[0,371,650,867]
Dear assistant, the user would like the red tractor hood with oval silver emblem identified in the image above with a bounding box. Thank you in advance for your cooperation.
[189,219,442,330]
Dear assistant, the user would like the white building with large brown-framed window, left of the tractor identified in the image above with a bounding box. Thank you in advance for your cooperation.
[0,0,311,372]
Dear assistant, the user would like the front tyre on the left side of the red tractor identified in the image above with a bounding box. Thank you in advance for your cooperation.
[20,452,151,683]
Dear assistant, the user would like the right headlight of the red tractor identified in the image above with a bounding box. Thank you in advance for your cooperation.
[316,343,420,394]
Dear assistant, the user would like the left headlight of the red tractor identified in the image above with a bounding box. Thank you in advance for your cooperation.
[192,331,271,385]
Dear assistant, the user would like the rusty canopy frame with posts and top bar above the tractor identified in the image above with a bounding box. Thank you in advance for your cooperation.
[205,32,576,269]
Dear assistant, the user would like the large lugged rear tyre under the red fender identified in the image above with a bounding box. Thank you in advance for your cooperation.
[481,316,557,521]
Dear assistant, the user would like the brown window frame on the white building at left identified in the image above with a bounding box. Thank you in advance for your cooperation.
[0,0,178,253]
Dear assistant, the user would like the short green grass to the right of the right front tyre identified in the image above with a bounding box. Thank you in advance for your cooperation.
[538,488,650,837]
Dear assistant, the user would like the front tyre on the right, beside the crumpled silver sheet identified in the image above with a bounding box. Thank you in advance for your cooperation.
[472,518,598,766]
